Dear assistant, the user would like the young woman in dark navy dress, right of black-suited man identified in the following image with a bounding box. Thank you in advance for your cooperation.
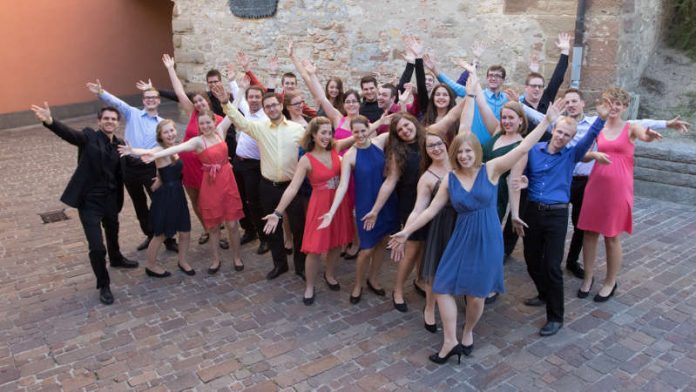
[118,120,196,278]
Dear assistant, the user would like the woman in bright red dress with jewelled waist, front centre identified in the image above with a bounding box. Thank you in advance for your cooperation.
[263,117,353,306]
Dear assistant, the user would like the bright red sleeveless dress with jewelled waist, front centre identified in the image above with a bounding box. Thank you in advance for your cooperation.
[302,150,353,254]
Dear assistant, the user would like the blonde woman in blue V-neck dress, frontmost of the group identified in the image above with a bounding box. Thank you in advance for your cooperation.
[390,100,565,363]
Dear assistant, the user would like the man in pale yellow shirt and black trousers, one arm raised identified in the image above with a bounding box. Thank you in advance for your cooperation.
[213,86,305,280]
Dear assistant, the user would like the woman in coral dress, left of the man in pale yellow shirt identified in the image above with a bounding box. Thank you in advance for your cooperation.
[142,111,244,275]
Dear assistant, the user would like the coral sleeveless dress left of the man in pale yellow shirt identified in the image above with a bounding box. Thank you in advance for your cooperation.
[198,133,244,229]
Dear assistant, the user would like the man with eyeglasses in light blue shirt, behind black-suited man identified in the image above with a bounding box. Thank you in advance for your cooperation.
[87,79,179,252]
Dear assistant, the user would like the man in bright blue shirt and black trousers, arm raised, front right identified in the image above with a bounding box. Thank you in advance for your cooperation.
[513,102,610,336]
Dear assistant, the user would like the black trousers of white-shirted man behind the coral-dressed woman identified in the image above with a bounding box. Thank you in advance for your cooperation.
[233,157,267,241]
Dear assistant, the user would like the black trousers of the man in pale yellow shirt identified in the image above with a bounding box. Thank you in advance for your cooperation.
[259,177,306,273]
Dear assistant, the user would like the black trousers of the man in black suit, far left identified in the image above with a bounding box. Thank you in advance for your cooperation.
[77,192,123,289]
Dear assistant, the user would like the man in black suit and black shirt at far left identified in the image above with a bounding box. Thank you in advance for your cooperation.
[31,102,138,305]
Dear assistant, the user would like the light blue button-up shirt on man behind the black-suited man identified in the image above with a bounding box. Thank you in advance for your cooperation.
[99,91,162,149]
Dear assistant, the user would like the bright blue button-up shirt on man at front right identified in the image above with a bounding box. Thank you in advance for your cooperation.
[525,117,604,204]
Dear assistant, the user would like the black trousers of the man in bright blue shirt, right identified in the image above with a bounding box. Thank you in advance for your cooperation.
[523,203,568,322]
